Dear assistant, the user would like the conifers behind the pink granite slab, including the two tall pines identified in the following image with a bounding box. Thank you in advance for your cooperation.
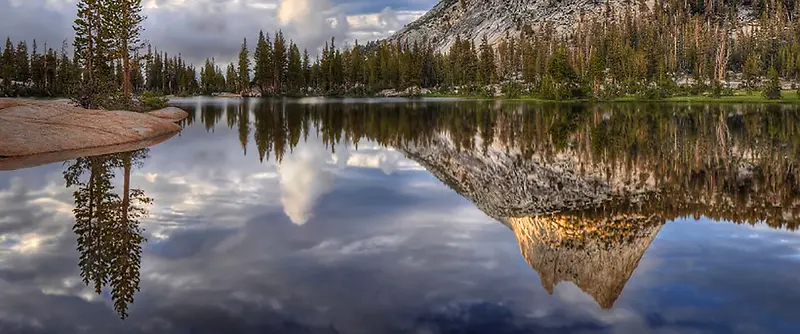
[7,0,200,109]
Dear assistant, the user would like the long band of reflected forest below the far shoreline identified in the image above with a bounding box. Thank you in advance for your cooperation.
[188,100,800,229]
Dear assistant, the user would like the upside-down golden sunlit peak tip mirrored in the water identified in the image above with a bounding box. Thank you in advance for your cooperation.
[503,215,664,308]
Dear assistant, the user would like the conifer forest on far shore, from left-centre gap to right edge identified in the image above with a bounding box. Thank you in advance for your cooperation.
[195,0,800,100]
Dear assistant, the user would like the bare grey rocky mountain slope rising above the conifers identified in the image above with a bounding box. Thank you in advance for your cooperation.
[390,0,752,51]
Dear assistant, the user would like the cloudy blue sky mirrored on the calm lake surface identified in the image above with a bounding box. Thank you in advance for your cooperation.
[0,100,800,333]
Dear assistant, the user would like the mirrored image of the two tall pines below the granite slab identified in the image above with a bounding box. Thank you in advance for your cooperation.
[64,149,152,318]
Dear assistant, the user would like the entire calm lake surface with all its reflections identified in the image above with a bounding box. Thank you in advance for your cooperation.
[0,98,800,333]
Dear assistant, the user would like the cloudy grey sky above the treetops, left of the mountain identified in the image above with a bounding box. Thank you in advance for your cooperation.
[0,0,437,63]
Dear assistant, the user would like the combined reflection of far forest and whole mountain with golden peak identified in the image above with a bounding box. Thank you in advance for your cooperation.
[186,100,800,308]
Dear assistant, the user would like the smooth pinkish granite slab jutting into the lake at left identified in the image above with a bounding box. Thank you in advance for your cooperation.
[0,99,188,169]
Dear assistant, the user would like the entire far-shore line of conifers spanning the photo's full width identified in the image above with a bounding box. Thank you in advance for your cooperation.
[0,0,800,100]
